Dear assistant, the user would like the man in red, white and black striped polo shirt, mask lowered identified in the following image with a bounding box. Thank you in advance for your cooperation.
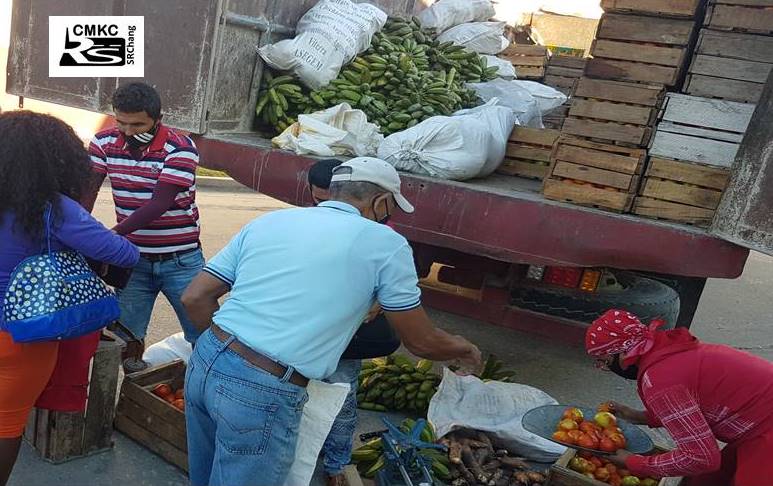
[89,83,204,343]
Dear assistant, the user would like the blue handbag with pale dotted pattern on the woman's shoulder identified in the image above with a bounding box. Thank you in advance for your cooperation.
[2,206,120,343]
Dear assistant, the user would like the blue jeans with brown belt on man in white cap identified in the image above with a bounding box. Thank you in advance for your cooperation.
[185,330,308,486]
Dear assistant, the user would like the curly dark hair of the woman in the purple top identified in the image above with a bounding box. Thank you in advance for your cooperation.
[0,110,93,238]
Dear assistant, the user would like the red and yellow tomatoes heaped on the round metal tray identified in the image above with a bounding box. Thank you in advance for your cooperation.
[553,404,626,452]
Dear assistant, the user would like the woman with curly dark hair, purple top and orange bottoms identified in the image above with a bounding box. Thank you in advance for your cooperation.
[0,111,139,486]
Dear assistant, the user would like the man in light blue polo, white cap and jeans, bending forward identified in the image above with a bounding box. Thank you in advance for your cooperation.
[183,157,480,486]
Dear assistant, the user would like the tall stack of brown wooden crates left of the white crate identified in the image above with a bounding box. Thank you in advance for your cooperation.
[543,0,701,212]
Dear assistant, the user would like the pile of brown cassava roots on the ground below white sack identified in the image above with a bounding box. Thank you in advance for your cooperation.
[439,428,547,486]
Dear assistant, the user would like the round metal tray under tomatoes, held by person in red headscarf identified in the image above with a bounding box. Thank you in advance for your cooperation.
[521,405,655,455]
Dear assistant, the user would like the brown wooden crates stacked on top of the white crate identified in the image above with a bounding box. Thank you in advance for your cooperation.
[683,0,773,103]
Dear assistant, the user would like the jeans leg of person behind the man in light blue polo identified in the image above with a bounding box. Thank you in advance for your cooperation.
[322,359,362,476]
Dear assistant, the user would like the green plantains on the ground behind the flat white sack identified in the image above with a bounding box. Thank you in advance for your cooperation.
[357,354,513,415]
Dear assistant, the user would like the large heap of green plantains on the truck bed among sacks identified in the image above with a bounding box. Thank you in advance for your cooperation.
[256,17,498,135]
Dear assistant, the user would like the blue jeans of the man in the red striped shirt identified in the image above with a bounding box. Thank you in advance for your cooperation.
[118,250,204,343]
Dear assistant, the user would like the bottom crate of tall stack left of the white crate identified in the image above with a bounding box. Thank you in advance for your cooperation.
[543,135,647,212]
